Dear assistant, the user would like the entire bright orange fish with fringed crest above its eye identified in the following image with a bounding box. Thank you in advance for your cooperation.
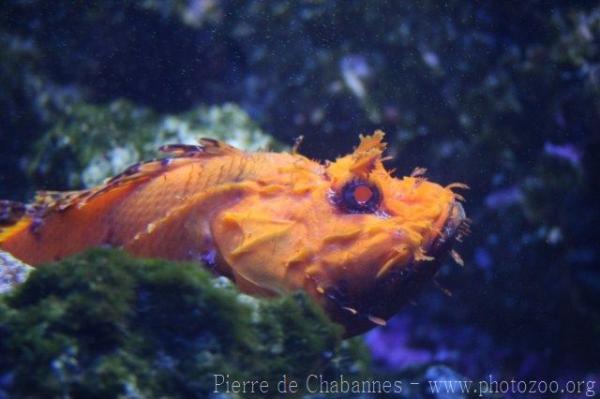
[0,131,468,335]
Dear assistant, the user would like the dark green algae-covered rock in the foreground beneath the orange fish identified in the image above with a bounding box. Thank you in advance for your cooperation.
[0,249,370,397]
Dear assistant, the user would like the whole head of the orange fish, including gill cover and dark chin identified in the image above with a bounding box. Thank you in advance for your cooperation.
[214,131,466,335]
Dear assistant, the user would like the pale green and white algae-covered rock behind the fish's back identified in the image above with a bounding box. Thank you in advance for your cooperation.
[29,100,279,188]
